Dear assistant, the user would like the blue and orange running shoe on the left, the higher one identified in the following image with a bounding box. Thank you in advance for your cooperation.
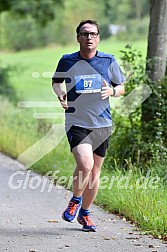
[62,200,81,222]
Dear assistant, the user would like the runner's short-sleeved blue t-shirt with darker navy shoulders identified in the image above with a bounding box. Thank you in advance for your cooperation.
[52,51,125,129]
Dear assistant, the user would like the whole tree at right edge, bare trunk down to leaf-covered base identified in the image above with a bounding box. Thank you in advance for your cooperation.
[142,0,167,163]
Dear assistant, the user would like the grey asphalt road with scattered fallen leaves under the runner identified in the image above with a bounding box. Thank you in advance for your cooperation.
[0,154,167,252]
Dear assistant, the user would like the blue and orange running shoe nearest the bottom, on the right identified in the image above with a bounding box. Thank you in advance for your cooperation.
[77,215,97,232]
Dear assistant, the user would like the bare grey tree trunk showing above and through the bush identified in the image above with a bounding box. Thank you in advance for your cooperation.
[142,0,167,122]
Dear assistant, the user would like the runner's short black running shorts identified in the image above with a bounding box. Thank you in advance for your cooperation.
[67,125,111,157]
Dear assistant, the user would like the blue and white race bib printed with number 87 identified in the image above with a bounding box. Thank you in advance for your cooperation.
[75,74,102,94]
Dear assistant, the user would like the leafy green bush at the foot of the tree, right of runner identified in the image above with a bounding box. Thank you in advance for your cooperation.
[105,45,167,171]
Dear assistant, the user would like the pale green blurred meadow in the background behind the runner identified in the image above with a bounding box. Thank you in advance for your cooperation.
[1,40,147,100]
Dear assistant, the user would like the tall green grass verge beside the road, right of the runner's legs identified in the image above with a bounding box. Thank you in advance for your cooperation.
[96,168,167,237]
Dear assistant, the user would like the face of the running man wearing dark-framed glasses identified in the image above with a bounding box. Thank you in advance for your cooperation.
[77,24,100,51]
